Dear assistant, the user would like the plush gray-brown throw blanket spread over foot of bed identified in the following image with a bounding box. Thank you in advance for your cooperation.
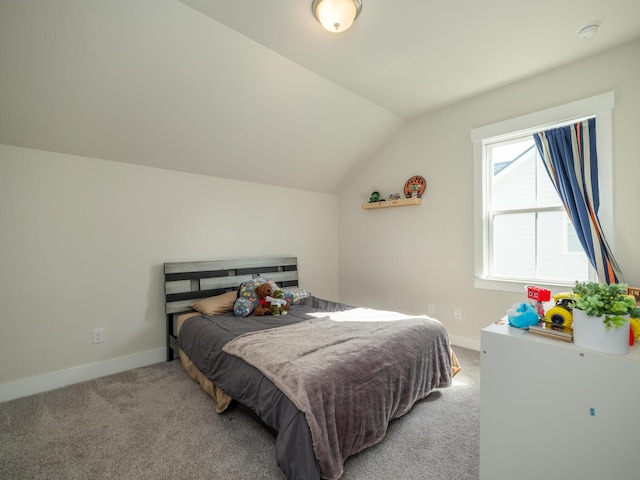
[223,309,451,479]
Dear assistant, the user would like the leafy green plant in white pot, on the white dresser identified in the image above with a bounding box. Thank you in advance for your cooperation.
[572,282,640,355]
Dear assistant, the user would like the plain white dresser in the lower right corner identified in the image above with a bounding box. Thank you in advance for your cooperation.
[480,324,640,480]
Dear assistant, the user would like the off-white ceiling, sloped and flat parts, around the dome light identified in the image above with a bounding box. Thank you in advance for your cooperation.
[0,0,640,193]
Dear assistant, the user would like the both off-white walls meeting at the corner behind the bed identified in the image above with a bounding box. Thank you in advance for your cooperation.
[0,38,640,400]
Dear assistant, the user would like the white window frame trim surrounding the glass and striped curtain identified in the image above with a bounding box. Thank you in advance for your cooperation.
[471,91,615,293]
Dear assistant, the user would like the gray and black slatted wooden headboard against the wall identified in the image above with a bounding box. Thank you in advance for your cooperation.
[164,257,298,361]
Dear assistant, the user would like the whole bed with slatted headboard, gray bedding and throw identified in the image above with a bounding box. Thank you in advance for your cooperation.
[165,257,459,480]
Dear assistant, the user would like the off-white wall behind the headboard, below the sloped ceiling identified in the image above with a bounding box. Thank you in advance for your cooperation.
[0,145,338,400]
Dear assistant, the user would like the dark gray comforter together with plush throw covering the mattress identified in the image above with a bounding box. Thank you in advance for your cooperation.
[178,297,451,480]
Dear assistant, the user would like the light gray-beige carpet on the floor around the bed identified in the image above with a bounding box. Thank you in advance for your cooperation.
[0,347,480,480]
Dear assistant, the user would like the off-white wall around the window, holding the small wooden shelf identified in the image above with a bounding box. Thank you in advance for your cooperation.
[340,41,640,344]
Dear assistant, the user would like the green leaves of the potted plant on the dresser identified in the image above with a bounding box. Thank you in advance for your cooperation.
[573,282,640,329]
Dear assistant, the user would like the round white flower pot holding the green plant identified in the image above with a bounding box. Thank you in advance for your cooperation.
[572,308,629,355]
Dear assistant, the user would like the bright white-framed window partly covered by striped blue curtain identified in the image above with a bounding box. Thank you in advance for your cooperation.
[471,92,613,292]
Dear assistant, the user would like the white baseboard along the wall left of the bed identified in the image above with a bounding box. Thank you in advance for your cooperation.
[0,348,167,402]
